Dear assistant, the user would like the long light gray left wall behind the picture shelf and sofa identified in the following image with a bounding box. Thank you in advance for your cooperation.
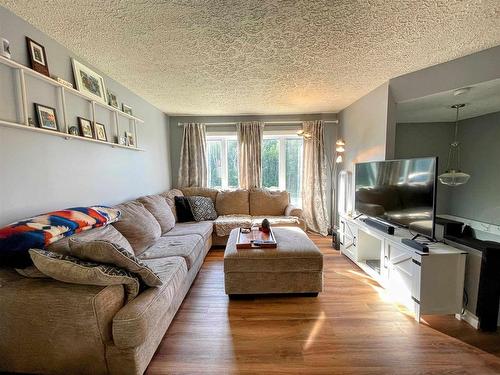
[0,7,170,225]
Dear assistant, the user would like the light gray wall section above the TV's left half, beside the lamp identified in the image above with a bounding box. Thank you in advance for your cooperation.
[339,83,394,172]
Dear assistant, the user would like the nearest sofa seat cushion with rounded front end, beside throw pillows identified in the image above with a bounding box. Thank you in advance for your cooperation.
[113,257,187,349]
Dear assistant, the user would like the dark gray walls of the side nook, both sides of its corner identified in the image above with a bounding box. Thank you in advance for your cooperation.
[396,112,500,225]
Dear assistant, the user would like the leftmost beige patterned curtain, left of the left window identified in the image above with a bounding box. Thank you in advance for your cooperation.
[178,123,207,187]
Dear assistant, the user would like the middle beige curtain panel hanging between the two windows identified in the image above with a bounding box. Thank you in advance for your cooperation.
[237,121,264,189]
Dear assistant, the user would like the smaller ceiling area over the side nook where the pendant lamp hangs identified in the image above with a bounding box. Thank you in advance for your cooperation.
[397,79,500,123]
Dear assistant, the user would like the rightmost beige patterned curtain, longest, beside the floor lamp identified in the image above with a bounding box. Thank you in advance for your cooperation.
[302,121,329,236]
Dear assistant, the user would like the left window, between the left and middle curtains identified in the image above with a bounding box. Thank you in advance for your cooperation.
[207,136,238,189]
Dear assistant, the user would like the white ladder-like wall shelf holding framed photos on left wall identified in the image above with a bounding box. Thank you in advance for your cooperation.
[0,56,144,151]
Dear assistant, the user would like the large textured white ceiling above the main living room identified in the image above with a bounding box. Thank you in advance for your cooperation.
[0,0,500,115]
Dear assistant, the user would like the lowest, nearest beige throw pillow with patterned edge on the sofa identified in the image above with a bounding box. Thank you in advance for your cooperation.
[29,249,140,302]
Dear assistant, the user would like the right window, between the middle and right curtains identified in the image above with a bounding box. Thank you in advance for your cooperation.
[262,135,302,206]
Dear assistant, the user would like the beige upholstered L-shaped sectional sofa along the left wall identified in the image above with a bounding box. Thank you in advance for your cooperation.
[0,188,303,375]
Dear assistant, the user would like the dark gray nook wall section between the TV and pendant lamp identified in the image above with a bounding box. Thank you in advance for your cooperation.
[395,122,454,214]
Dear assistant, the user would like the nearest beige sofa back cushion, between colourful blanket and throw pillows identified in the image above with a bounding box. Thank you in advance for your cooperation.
[47,225,134,255]
